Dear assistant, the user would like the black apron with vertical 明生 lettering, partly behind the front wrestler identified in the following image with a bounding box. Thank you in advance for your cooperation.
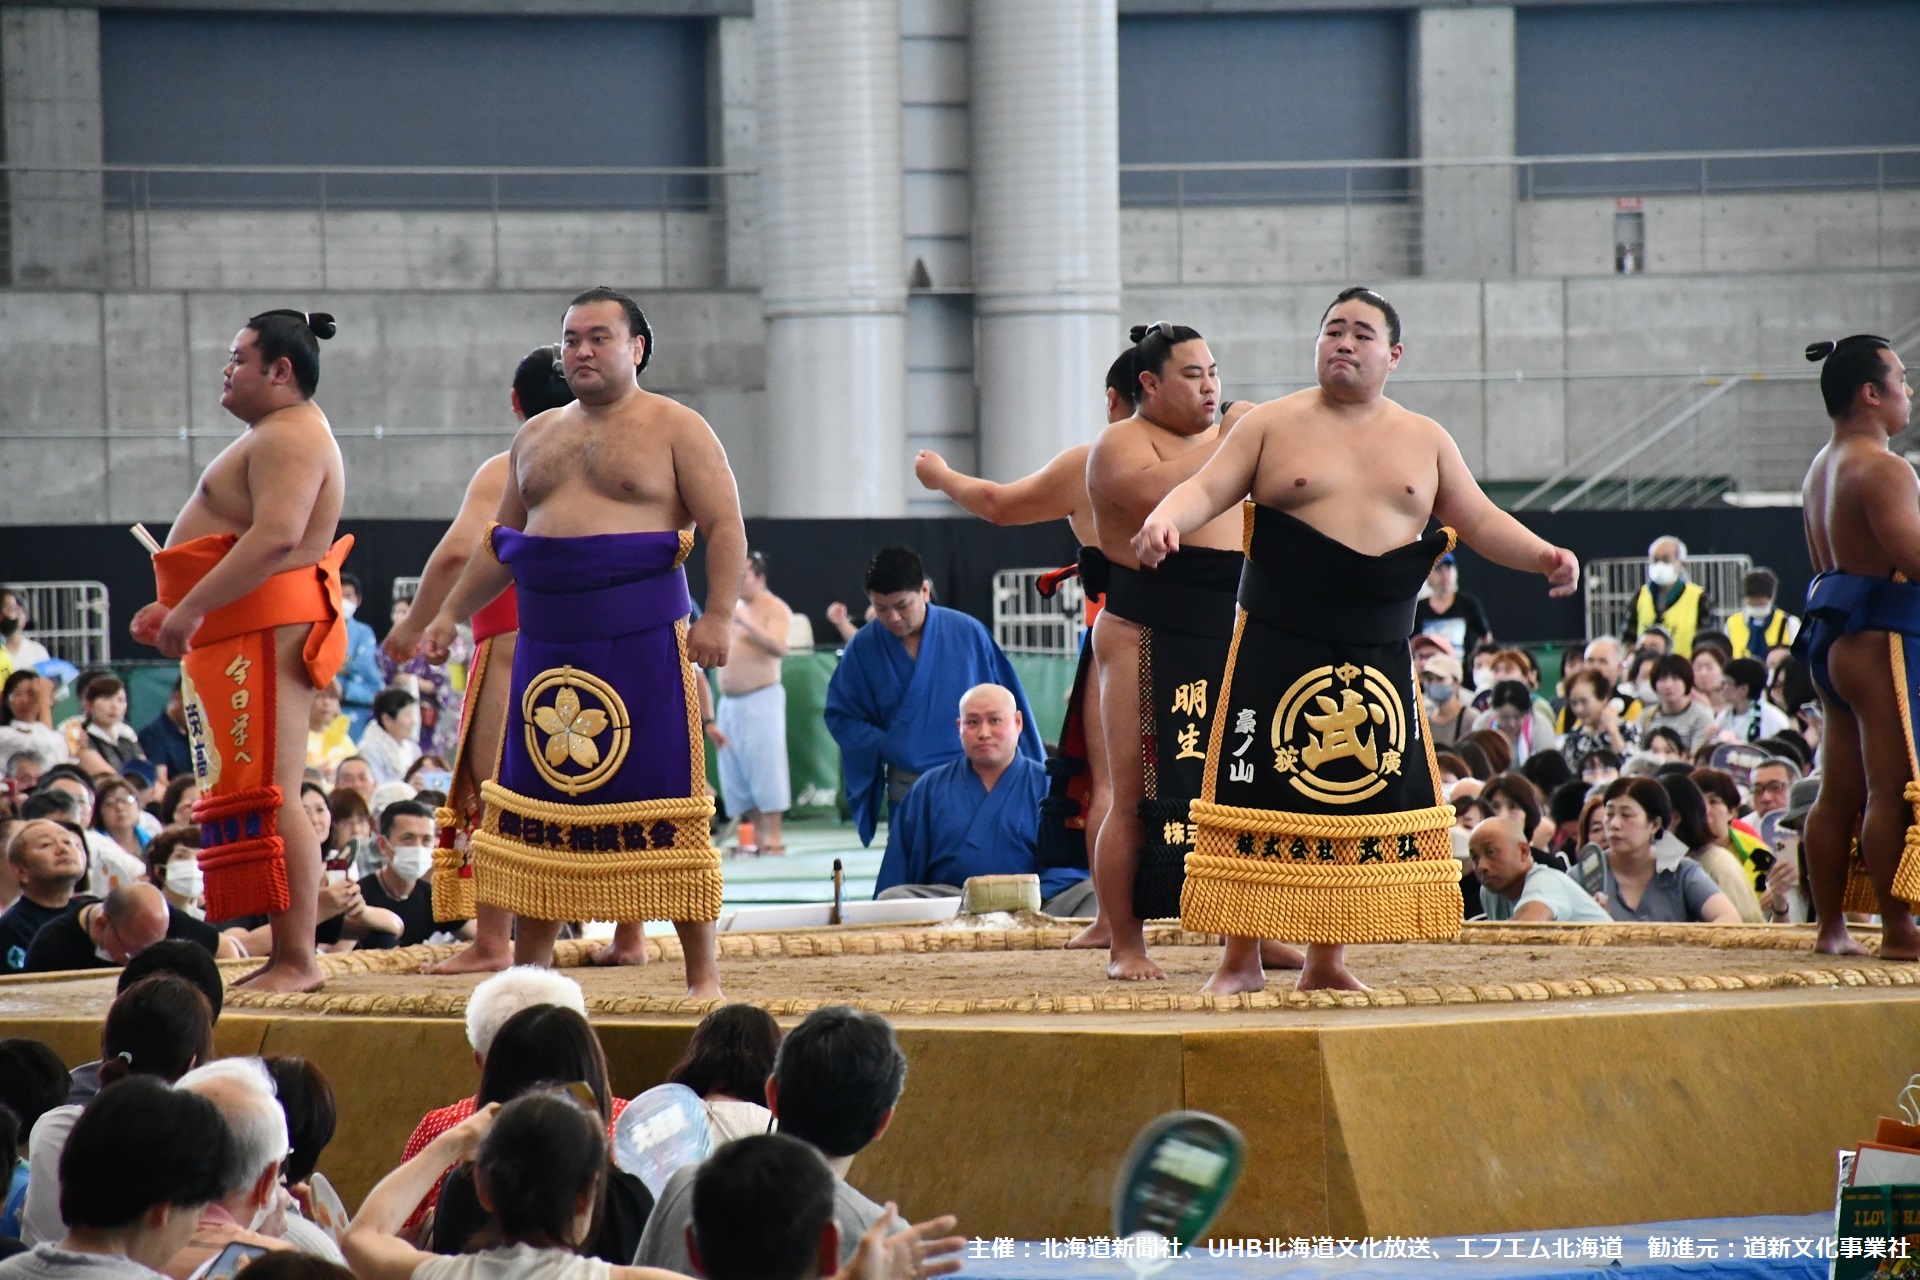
[1106,547,1246,919]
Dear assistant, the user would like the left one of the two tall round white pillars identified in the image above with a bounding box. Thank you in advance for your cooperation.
[755,0,906,516]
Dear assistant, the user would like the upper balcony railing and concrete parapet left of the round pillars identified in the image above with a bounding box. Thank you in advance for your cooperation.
[0,165,755,290]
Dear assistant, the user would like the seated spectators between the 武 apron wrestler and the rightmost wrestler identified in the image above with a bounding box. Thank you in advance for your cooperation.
[1413,537,1822,923]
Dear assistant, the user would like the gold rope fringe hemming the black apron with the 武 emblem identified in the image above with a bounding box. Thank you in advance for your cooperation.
[1181,800,1463,944]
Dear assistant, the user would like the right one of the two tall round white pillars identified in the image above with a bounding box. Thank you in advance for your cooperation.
[972,0,1121,480]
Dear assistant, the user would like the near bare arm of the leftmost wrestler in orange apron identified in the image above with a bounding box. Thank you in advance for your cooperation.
[154,418,332,658]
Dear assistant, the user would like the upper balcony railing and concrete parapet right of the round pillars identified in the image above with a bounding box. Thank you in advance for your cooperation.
[1119,146,1920,284]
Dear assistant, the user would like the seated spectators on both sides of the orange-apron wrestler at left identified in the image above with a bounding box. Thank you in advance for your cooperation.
[0,578,487,973]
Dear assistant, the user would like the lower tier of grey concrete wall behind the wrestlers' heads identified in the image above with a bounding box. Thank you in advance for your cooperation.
[0,269,1920,524]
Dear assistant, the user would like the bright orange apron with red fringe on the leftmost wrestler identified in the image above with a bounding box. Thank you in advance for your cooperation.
[154,533,353,919]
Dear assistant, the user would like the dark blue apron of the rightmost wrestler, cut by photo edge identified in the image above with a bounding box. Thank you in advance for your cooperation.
[1793,570,1920,913]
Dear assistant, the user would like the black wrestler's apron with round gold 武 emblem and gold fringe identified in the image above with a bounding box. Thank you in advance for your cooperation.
[1181,503,1461,942]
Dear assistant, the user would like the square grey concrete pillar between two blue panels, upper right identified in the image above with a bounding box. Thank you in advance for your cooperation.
[1413,8,1517,280]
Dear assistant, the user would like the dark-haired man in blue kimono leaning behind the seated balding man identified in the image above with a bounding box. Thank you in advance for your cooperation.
[826,547,1046,844]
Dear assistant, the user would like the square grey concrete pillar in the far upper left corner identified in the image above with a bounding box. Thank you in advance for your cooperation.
[0,8,106,288]
